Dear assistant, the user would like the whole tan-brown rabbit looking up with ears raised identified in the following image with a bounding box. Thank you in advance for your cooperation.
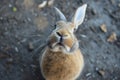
[40,4,87,80]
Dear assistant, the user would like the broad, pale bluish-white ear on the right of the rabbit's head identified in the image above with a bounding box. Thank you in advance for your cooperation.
[73,4,87,30]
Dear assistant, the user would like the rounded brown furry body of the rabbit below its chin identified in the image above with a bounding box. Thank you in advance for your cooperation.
[41,48,84,80]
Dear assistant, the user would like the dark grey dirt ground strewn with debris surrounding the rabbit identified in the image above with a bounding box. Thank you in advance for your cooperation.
[0,0,120,80]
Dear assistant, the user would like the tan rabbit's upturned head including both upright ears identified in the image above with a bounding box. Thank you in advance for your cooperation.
[48,4,87,53]
